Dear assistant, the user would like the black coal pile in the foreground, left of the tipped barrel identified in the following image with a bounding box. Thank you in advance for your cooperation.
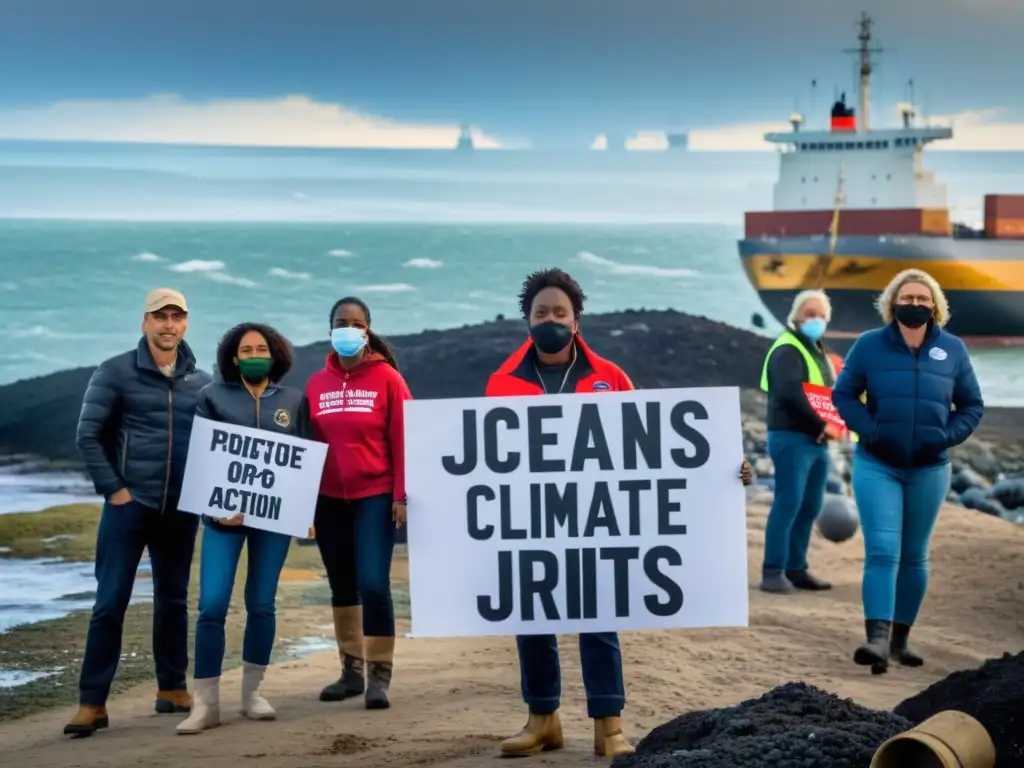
[613,683,910,768]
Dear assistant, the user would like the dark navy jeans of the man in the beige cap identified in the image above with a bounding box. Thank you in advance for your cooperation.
[79,501,199,707]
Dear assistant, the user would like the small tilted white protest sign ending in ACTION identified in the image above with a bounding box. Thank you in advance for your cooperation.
[178,416,327,539]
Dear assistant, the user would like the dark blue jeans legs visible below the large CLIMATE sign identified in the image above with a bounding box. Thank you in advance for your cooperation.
[515,632,626,718]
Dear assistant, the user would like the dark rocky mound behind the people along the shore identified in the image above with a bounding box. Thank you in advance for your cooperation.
[0,310,771,461]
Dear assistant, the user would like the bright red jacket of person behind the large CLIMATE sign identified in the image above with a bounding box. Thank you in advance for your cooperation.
[484,335,634,397]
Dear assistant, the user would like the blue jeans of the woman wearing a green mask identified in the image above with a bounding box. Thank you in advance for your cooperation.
[196,525,292,680]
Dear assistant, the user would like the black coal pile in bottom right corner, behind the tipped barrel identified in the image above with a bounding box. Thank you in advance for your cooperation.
[895,651,1024,768]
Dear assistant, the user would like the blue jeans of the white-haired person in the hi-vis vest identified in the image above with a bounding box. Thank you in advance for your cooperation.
[763,429,828,571]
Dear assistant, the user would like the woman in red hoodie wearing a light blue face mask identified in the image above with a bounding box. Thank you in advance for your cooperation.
[306,296,413,710]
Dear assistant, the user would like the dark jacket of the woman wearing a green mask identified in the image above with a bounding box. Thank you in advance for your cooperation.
[196,381,309,532]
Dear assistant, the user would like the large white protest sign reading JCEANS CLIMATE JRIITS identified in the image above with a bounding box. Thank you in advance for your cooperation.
[406,387,748,637]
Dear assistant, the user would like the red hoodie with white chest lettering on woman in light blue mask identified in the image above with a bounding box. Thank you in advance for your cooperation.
[306,352,413,501]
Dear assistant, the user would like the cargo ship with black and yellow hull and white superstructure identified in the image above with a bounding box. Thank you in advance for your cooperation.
[738,13,1024,351]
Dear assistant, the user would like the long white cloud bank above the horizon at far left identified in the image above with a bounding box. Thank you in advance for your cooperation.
[0,94,508,150]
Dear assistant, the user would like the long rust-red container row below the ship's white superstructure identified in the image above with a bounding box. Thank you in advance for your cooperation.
[745,208,950,238]
